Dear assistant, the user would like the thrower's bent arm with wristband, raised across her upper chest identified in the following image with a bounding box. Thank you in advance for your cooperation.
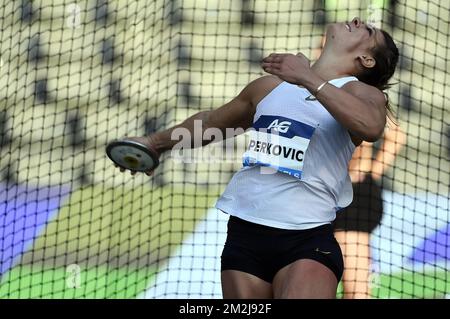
[262,53,387,142]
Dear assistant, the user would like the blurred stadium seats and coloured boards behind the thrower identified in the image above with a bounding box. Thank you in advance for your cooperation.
[0,0,450,298]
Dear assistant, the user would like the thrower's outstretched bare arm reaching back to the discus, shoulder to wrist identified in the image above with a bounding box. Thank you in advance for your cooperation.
[146,75,282,153]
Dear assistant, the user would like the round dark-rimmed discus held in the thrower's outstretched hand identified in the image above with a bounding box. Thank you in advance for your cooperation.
[106,139,159,172]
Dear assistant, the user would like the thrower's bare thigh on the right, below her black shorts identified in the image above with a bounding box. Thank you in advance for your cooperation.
[273,259,338,299]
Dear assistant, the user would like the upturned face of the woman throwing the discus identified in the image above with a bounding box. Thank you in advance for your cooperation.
[326,18,384,67]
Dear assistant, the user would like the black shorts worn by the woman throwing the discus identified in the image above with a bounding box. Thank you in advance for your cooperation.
[221,216,344,283]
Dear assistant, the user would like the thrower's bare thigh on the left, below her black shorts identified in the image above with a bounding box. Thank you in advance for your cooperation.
[221,270,273,299]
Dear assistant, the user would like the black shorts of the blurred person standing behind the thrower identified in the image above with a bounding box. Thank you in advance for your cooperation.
[333,175,383,233]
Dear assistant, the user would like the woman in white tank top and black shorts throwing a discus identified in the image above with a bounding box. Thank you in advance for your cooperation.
[114,18,399,298]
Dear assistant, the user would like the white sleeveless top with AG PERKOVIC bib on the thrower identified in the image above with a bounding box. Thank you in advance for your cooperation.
[216,77,357,229]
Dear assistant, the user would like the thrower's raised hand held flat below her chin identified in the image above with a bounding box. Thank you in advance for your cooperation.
[261,53,312,85]
